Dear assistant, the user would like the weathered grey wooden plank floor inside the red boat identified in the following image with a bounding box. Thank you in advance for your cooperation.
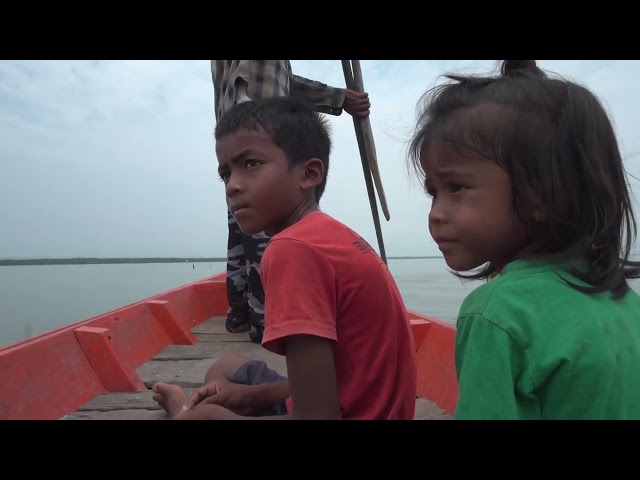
[62,317,451,420]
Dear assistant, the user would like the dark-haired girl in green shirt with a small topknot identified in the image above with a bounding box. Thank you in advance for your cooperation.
[410,60,640,419]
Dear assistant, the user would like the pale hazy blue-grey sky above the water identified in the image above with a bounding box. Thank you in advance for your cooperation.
[0,60,640,258]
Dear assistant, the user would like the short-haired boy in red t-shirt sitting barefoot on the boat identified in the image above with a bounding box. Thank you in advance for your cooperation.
[153,97,416,420]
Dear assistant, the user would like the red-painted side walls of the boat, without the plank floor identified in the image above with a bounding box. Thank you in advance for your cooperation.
[0,273,458,420]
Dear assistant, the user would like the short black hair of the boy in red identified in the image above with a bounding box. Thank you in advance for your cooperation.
[215,97,331,201]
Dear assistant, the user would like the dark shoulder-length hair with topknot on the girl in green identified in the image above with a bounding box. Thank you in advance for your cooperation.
[410,60,640,298]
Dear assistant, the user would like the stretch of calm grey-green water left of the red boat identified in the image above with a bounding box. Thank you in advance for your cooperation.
[0,263,225,346]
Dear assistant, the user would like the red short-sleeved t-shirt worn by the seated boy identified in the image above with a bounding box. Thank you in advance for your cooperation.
[261,212,417,420]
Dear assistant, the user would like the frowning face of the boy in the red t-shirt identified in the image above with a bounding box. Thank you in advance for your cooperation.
[216,130,305,235]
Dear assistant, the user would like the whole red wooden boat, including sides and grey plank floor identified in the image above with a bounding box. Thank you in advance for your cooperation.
[0,272,458,420]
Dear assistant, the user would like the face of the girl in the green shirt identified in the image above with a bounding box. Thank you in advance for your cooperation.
[421,143,526,272]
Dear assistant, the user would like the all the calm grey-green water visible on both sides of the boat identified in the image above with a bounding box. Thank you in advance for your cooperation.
[0,258,640,346]
